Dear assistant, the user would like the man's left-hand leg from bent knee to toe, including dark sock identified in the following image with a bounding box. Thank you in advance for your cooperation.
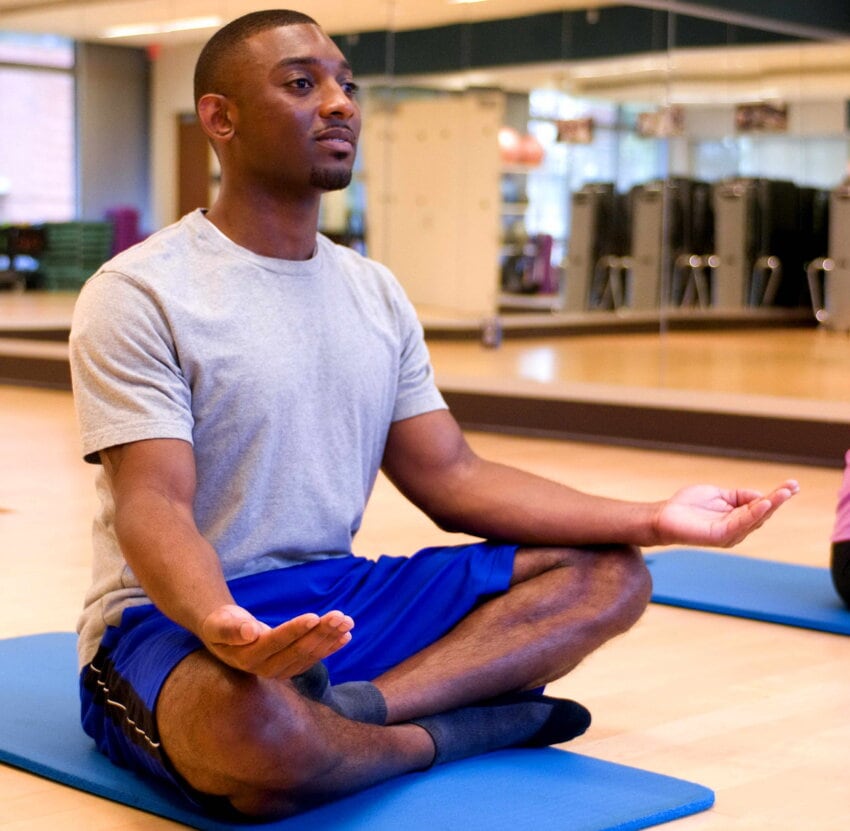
[157,651,589,818]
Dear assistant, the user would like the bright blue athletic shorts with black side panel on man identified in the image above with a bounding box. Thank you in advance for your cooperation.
[80,543,516,808]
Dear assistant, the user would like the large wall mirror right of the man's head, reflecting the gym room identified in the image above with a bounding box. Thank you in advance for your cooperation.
[337,7,850,412]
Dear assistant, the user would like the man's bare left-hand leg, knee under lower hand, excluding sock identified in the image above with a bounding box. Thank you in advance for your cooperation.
[156,650,434,817]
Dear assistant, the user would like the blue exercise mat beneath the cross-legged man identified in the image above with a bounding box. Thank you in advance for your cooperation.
[0,632,714,831]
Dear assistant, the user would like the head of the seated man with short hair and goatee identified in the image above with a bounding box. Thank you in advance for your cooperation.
[195,10,360,197]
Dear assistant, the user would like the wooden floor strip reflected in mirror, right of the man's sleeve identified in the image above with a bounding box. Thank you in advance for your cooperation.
[430,329,850,402]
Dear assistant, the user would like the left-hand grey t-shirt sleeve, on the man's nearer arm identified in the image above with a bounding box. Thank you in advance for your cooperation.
[70,272,194,462]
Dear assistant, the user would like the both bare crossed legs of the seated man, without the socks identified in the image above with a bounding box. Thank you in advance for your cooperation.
[157,547,650,817]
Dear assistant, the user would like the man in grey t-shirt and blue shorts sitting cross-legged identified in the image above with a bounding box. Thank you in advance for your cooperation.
[72,11,797,817]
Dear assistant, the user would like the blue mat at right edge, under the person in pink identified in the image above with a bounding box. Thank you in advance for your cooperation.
[646,548,850,635]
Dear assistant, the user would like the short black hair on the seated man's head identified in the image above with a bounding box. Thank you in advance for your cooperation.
[195,9,319,106]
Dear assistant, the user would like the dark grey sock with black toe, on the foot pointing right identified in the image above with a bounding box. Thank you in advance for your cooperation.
[412,693,590,765]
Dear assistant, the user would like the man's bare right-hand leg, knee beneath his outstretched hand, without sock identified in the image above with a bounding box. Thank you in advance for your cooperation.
[374,546,651,724]
